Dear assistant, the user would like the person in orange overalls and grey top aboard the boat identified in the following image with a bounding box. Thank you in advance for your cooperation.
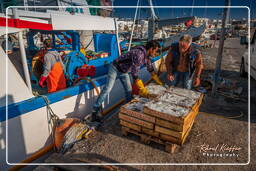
[39,39,66,93]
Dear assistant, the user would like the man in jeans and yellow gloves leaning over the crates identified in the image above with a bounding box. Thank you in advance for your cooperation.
[91,40,163,122]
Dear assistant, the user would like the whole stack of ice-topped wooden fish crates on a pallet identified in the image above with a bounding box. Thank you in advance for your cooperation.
[119,85,203,152]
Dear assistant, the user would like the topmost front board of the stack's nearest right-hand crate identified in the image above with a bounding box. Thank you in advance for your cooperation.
[143,107,184,124]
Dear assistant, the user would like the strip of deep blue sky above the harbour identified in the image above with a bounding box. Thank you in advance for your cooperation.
[114,0,256,19]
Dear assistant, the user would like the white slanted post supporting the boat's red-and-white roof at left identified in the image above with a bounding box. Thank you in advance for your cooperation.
[13,8,32,92]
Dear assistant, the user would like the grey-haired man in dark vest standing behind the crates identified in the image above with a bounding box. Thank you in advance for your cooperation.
[165,34,203,89]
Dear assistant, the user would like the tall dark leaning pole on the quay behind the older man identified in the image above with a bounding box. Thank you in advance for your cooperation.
[212,0,231,96]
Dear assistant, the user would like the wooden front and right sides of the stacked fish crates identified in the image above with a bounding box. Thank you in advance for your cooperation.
[119,95,203,145]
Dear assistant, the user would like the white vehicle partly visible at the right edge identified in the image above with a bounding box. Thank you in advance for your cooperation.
[240,28,256,80]
